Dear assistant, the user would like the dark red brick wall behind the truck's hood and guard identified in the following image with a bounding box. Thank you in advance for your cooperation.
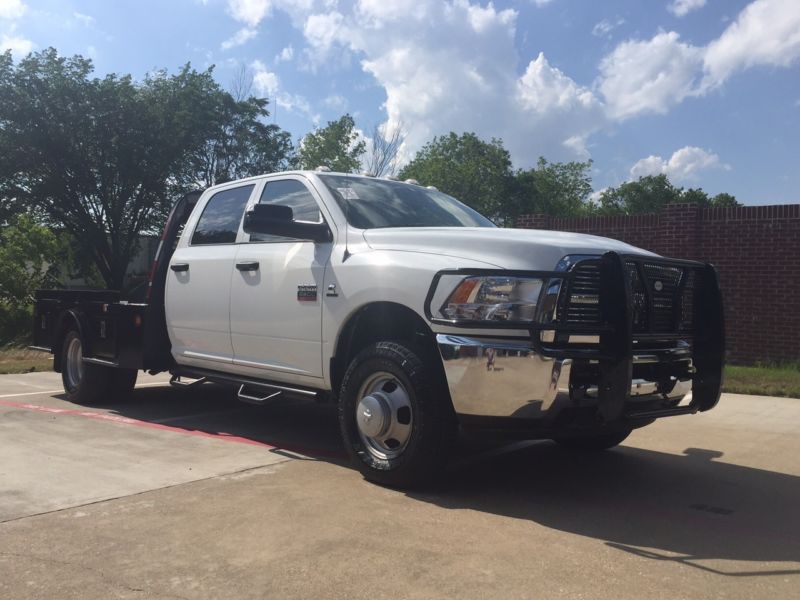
[517,204,800,363]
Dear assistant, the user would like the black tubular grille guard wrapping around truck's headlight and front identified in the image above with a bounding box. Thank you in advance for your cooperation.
[425,252,725,420]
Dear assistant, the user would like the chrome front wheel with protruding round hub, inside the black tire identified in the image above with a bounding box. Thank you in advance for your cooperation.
[355,372,413,460]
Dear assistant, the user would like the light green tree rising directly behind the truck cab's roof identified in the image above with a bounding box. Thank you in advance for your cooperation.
[297,115,366,173]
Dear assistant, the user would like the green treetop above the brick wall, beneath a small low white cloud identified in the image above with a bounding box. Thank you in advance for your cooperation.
[599,174,681,215]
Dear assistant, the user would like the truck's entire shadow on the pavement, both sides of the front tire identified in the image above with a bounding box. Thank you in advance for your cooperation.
[92,384,800,577]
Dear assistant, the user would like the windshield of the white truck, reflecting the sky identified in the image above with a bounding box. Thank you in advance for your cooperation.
[319,175,495,229]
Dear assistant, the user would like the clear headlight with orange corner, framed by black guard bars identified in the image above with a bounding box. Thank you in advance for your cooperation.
[439,276,542,322]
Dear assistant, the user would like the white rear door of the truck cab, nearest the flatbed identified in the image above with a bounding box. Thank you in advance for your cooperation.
[166,184,255,368]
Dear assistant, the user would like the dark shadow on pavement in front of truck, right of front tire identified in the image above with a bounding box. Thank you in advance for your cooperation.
[411,442,800,576]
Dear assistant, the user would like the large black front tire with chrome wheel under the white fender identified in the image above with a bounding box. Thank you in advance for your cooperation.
[339,342,456,487]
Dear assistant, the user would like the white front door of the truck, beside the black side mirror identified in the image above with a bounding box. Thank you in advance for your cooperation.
[230,177,332,381]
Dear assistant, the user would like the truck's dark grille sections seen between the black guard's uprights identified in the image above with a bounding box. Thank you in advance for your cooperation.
[557,259,698,335]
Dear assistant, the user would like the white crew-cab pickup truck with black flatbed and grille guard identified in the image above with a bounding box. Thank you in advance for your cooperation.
[34,171,724,486]
